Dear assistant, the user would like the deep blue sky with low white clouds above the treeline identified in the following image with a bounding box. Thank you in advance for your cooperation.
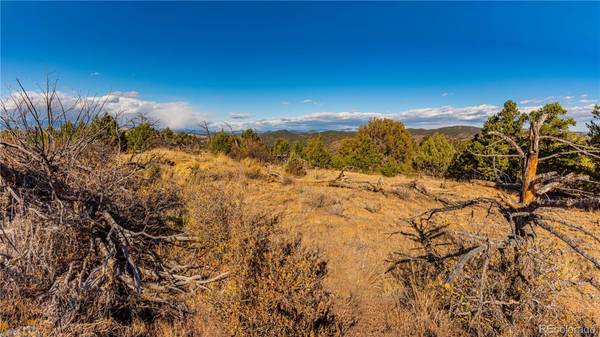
[0,1,600,129]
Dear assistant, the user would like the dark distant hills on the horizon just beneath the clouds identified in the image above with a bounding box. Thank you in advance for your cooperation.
[260,125,481,144]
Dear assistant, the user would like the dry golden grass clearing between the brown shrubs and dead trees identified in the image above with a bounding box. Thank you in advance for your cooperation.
[143,150,600,336]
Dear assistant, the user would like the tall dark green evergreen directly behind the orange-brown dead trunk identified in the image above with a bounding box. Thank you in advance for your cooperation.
[449,101,593,182]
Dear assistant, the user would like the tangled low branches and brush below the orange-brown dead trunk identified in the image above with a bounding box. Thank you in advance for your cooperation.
[388,192,600,335]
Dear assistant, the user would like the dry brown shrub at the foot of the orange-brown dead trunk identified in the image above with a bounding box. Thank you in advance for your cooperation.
[392,222,564,336]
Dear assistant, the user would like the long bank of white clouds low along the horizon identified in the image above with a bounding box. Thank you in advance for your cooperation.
[7,91,596,130]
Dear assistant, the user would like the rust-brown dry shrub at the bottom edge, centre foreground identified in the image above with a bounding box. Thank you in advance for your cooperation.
[213,216,346,336]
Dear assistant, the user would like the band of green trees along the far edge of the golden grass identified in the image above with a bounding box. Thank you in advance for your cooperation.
[118,100,600,185]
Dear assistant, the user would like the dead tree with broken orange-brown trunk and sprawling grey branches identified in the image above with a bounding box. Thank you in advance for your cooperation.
[388,112,600,335]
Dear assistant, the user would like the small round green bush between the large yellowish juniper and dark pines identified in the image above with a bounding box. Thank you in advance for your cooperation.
[414,133,456,177]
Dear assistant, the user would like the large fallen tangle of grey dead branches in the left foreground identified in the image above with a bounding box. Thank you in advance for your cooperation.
[0,81,226,335]
